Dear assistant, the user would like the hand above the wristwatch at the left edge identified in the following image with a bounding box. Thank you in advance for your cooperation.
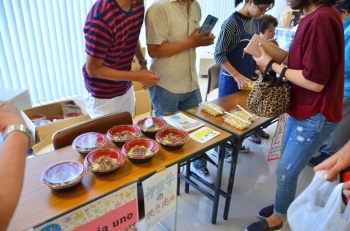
[0,101,25,132]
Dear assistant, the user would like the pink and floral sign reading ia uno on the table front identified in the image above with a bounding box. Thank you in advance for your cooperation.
[34,183,139,231]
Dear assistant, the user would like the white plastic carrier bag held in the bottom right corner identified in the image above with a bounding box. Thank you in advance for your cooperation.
[287,171,350,231]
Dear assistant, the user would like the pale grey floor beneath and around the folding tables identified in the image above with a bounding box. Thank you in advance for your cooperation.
[136,78,313,231]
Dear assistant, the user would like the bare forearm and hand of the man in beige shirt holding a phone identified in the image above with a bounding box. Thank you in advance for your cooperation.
[147,27,215,58]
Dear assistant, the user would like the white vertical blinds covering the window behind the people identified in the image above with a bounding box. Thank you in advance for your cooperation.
[0,0,288,105]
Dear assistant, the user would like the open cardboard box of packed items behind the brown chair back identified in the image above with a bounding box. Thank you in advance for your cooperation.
[22,100,91,144]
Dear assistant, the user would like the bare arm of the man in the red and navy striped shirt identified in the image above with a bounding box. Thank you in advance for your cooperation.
[86,54,160,86]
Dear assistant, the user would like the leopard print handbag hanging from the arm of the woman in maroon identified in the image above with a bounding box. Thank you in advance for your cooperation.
[246,61,291,117]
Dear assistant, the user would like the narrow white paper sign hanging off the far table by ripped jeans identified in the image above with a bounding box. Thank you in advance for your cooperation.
[267,113,288,161]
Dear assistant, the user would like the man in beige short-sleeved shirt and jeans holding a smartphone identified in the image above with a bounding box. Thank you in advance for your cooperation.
[146,0,215,183]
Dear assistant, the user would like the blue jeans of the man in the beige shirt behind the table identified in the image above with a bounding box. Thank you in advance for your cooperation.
[149,85,207,169]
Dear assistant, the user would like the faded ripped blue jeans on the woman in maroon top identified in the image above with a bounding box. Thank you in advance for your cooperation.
[274,113,338,217]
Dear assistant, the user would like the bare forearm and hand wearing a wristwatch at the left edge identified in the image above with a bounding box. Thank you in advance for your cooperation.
[0,101,29,230]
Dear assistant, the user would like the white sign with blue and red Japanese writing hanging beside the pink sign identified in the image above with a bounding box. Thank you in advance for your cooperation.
[142,164,178,231]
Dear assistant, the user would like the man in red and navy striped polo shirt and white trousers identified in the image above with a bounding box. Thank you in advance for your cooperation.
[83,0,160,118]
